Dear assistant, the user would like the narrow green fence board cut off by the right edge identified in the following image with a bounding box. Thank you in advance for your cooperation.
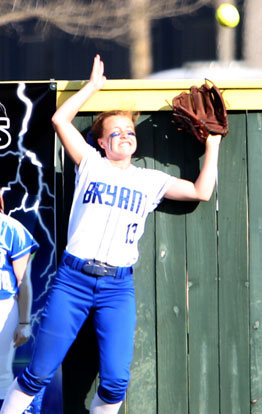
[247,112,262,414]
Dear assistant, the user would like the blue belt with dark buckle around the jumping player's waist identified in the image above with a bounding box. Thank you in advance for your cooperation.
[63,252,133,278]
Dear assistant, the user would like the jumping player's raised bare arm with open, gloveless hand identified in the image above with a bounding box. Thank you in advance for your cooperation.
[52,55,106,165]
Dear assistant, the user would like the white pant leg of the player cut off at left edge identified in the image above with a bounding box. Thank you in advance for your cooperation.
[0,297,19,399]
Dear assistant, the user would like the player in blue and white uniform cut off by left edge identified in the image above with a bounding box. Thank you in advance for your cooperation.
[0,194,38,413]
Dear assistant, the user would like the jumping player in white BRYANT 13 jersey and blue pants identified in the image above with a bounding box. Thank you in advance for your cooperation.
[1,56,221,414]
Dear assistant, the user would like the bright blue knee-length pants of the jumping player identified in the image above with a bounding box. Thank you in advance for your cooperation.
[18,252,136,403]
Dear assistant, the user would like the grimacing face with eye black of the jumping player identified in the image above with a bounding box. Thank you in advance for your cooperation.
[98,115,137,160]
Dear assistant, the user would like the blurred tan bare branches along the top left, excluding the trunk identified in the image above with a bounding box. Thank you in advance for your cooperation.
[0,0,212,42]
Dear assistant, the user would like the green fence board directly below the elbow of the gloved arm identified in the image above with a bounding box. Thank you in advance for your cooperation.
[187,184,219,414]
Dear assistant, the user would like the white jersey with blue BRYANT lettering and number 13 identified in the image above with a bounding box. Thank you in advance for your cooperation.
[66,145,173,267]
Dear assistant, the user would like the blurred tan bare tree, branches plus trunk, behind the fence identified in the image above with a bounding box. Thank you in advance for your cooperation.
[0,0,214,78]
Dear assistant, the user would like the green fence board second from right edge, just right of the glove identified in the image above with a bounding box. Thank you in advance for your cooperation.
[218,114,250,414]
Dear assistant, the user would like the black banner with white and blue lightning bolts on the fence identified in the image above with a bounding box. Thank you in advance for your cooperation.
[0,82,62,414]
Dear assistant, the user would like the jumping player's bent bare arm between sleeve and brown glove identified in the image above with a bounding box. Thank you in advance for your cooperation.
[165,135,221,201]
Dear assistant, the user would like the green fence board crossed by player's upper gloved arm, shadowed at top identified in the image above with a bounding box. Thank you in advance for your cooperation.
[154,114,188,414]
